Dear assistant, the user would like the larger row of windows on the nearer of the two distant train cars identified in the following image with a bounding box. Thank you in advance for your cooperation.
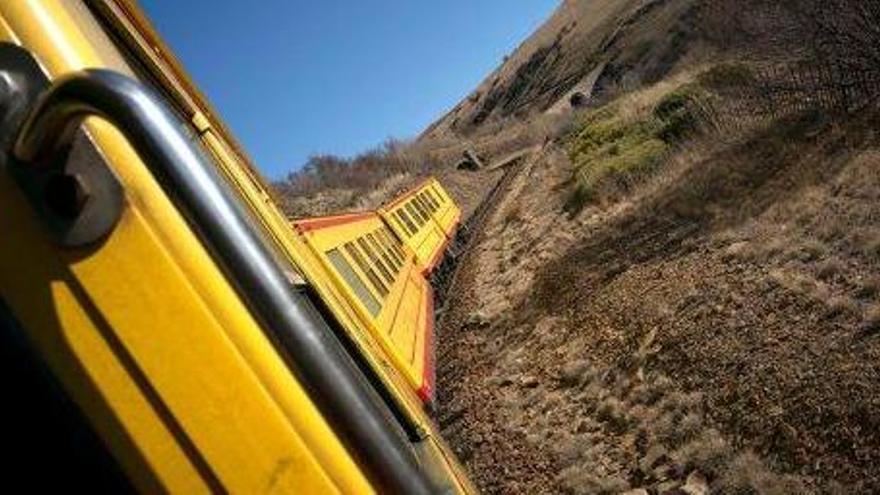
[326,226,406,316]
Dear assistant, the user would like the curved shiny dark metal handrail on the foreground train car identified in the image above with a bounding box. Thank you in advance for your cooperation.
[14,70,433,494]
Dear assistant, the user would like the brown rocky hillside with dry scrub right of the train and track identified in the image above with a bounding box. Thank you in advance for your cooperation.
[425,0,880,495]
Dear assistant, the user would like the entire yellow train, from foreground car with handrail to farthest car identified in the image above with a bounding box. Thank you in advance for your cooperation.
[0,0,474,494]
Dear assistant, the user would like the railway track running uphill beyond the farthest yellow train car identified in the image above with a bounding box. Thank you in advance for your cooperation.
[431,151,537,314]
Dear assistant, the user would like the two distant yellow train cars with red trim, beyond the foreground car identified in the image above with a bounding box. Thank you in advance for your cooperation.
[293,179,461,406]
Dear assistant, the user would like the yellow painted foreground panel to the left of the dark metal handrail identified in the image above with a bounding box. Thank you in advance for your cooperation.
[0,0,372,493]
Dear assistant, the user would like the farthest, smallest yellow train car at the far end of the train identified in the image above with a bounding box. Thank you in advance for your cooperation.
[379,179,452,276]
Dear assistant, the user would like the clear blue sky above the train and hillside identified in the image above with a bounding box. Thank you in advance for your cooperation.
[140,0,558,179]
